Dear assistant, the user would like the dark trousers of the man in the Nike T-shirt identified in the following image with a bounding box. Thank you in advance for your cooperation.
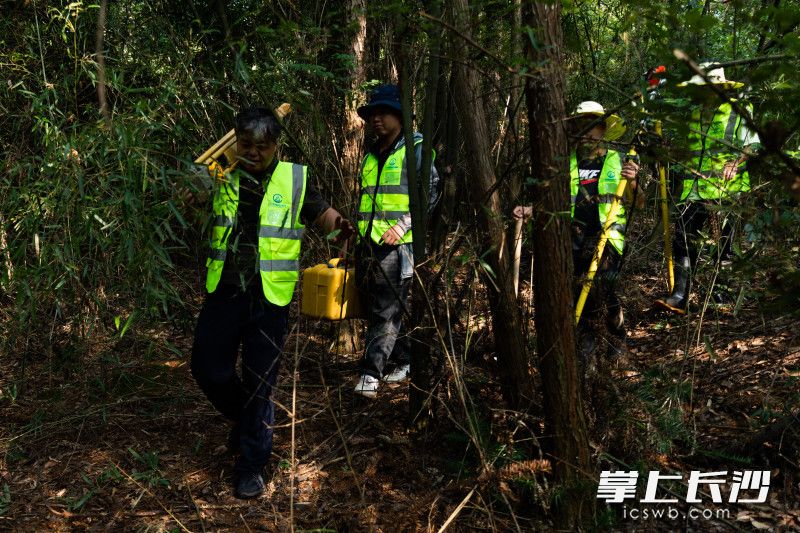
[572,231,625,338]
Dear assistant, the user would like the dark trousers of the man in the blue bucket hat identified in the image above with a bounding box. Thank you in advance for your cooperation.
[356,244,411,379]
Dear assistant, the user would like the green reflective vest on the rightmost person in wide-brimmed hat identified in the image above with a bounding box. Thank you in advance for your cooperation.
[681,102,752,200]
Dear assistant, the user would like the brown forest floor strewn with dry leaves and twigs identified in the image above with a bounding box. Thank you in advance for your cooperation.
[0,256,800,531]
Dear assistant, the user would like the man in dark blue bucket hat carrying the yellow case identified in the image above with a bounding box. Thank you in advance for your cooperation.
[354,85,439,398]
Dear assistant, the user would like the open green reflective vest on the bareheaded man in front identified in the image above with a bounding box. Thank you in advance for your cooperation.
[206,161,307,305]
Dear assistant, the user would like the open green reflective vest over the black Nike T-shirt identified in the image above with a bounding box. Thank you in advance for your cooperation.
[569,150,627,254]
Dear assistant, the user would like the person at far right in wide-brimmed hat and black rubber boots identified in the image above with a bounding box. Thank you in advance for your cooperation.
[656,63,759,314]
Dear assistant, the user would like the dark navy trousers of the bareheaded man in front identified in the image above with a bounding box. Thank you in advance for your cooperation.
[192,287,289,472]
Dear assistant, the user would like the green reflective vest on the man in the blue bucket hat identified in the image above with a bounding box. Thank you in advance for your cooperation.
[358,134,422,244]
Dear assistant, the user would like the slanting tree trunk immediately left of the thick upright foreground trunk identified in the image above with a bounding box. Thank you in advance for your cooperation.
[446,0,533,409]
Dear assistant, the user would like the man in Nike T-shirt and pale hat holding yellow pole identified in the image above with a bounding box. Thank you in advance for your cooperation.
[514,101,639,360]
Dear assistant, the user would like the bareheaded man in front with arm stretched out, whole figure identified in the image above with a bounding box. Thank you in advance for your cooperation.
[191,108,355,498]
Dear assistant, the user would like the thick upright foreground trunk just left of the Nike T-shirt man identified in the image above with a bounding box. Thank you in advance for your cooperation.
[525,2,593,530]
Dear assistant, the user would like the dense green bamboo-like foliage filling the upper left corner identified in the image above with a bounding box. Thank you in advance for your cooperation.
[0,0,376,368]
